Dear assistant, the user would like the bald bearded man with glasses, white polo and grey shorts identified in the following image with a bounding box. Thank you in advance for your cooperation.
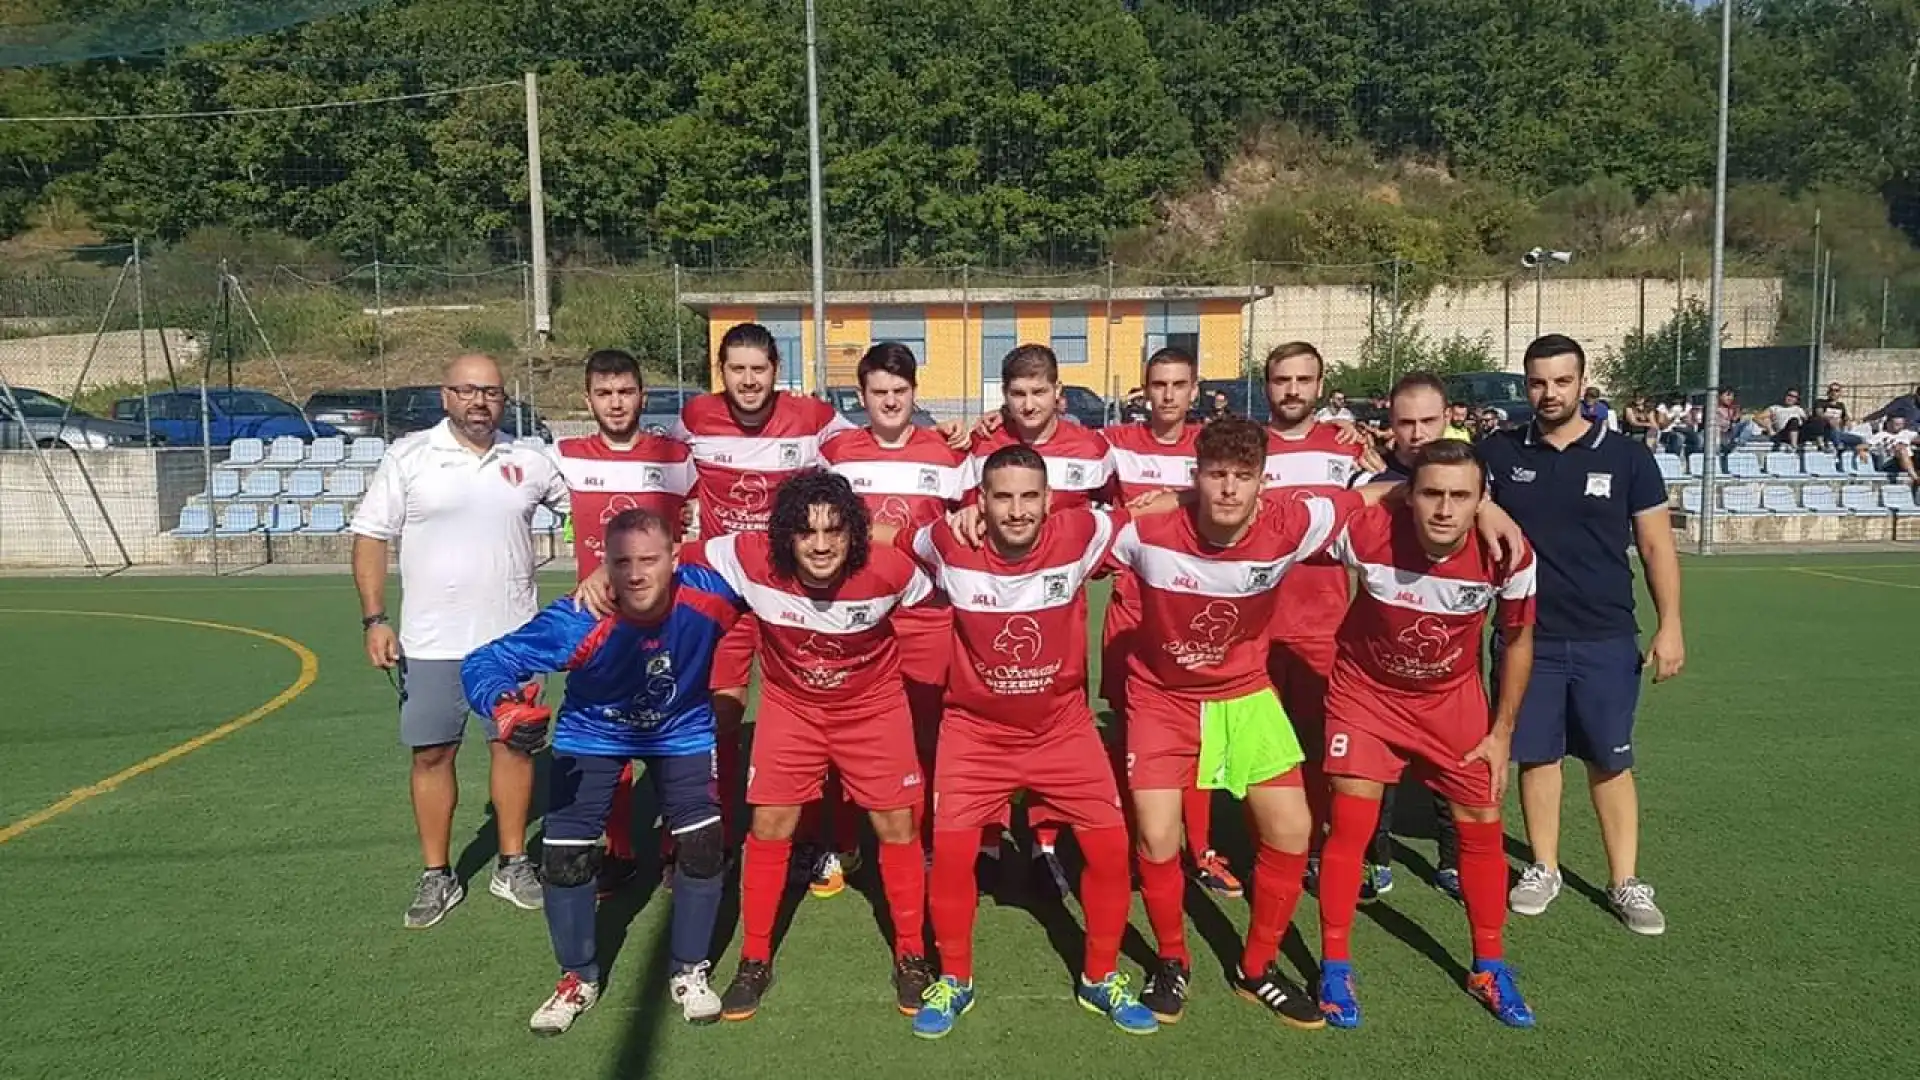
[348,356,566,930]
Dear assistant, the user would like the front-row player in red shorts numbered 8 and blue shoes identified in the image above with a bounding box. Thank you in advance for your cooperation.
[1319,440,1534,1028]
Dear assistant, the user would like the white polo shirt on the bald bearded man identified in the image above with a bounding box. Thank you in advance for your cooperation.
[348,421,566,659]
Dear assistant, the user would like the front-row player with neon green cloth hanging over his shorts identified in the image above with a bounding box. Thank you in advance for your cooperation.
[1114,419,1390,1028]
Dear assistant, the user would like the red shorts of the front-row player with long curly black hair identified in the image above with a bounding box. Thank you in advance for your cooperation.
[747,686,925,811]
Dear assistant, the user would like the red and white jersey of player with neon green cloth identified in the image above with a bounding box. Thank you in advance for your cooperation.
[1112,492,1361,700]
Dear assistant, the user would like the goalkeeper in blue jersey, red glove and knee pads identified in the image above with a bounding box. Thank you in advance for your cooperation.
[461,509,741,1036]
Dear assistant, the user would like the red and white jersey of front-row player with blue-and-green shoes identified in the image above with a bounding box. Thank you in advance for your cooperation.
[912,507,1117,730]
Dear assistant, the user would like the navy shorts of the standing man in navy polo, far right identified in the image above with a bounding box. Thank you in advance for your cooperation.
[1494,634,1644,773]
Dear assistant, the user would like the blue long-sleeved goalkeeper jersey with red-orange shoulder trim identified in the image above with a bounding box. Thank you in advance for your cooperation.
[461,567,741,757]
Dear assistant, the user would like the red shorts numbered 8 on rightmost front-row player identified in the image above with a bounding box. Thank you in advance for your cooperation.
[1325,667,1500,807]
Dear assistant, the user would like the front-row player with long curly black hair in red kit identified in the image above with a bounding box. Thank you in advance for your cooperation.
[682,469,933,1020]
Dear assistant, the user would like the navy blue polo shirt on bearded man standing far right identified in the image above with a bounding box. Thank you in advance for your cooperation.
[1480,425,1667,642]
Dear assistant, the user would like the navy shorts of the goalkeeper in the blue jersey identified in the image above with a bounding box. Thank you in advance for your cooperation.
[543,749,720,844]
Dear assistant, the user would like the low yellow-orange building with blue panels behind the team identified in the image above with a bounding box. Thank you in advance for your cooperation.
[682,286,1269,411]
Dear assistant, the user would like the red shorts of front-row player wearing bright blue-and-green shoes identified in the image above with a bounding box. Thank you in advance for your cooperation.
[933,709,1127,828]
